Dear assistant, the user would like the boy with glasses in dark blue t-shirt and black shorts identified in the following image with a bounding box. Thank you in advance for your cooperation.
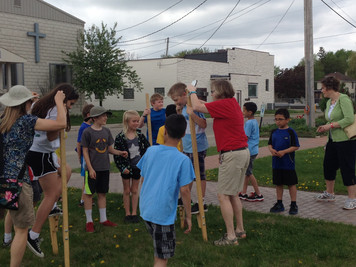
[268,108,299,215]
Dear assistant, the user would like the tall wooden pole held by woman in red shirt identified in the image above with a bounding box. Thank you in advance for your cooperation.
[187,90,208,241]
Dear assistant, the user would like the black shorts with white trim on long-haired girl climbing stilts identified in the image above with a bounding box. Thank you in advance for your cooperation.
[26,150,59,180]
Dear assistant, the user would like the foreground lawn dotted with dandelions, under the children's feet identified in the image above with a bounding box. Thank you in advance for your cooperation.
[0,188,356,267]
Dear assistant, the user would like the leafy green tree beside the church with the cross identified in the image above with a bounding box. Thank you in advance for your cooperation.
[63,23,142,105]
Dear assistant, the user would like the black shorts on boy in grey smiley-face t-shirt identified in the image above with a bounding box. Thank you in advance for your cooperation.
[84,170,110,195]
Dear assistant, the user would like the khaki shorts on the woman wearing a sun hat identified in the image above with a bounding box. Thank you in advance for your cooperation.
[9,183,35,228]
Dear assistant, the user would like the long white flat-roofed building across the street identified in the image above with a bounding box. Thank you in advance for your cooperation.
[87,48,274,110]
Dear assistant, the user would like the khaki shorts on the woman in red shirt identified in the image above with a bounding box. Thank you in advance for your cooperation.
[218,148,250,196]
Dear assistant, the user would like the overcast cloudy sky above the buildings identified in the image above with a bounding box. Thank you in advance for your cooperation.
[45,0,356,68]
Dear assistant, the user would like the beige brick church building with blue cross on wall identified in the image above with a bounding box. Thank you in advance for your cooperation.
[0,0,84,109]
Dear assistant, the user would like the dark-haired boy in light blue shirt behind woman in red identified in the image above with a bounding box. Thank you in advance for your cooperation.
[239,102,264,202]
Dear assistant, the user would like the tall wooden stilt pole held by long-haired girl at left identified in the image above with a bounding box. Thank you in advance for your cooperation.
[60,130,70,267]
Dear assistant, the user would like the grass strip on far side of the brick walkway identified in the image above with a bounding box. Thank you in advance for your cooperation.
[207,147,347,194]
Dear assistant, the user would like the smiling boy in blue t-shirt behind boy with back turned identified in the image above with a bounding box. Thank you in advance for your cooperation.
[138,94,166,145]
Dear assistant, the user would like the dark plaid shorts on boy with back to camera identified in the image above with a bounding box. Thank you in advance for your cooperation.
[145,221,176,259]
